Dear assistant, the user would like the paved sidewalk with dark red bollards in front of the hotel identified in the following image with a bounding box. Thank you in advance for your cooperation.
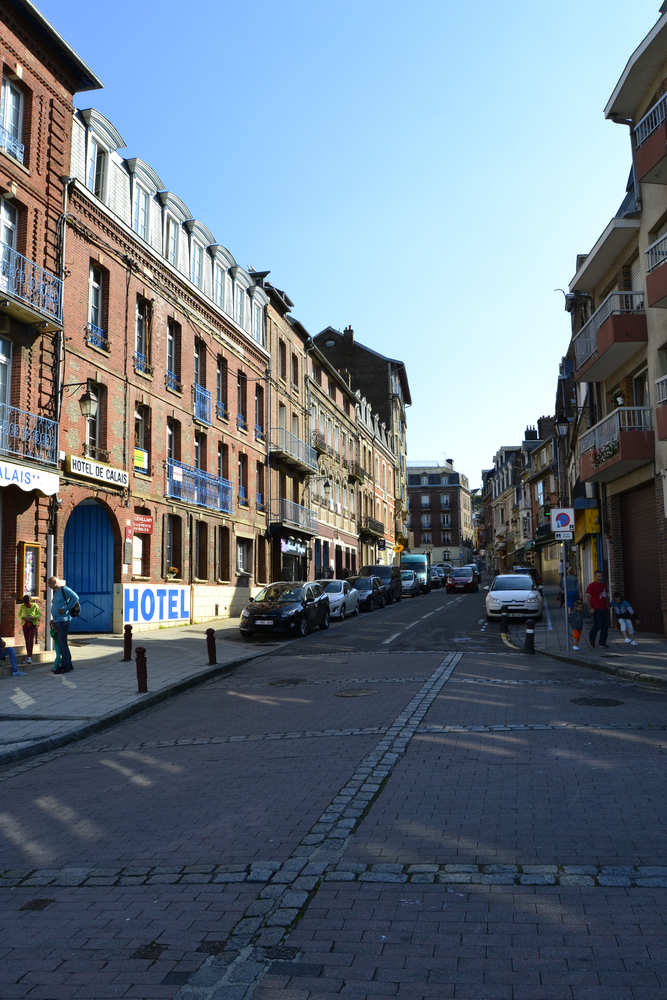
[0,618,276,764]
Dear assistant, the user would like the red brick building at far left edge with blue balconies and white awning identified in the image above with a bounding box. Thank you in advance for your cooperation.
[0,0,102,643]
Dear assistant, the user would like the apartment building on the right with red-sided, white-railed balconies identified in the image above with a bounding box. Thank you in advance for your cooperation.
[566,4,667,632]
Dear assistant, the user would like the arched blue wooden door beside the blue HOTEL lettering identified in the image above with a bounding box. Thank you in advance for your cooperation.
[64,500,113,632]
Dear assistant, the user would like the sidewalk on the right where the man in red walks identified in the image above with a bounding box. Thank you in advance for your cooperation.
[508,587,667,686]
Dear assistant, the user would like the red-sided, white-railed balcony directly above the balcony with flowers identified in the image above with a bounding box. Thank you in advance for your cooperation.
[572,292,647,382]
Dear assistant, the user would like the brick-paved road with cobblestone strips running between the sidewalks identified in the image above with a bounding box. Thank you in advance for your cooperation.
[0,593,667,1000]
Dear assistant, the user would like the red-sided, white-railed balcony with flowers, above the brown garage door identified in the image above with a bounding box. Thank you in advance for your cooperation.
[579,406,655,482]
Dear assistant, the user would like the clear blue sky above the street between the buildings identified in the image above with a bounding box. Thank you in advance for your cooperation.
[41,0,660,485]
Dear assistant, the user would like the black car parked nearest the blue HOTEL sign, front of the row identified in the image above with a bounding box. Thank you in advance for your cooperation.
[239,583,329,637]
